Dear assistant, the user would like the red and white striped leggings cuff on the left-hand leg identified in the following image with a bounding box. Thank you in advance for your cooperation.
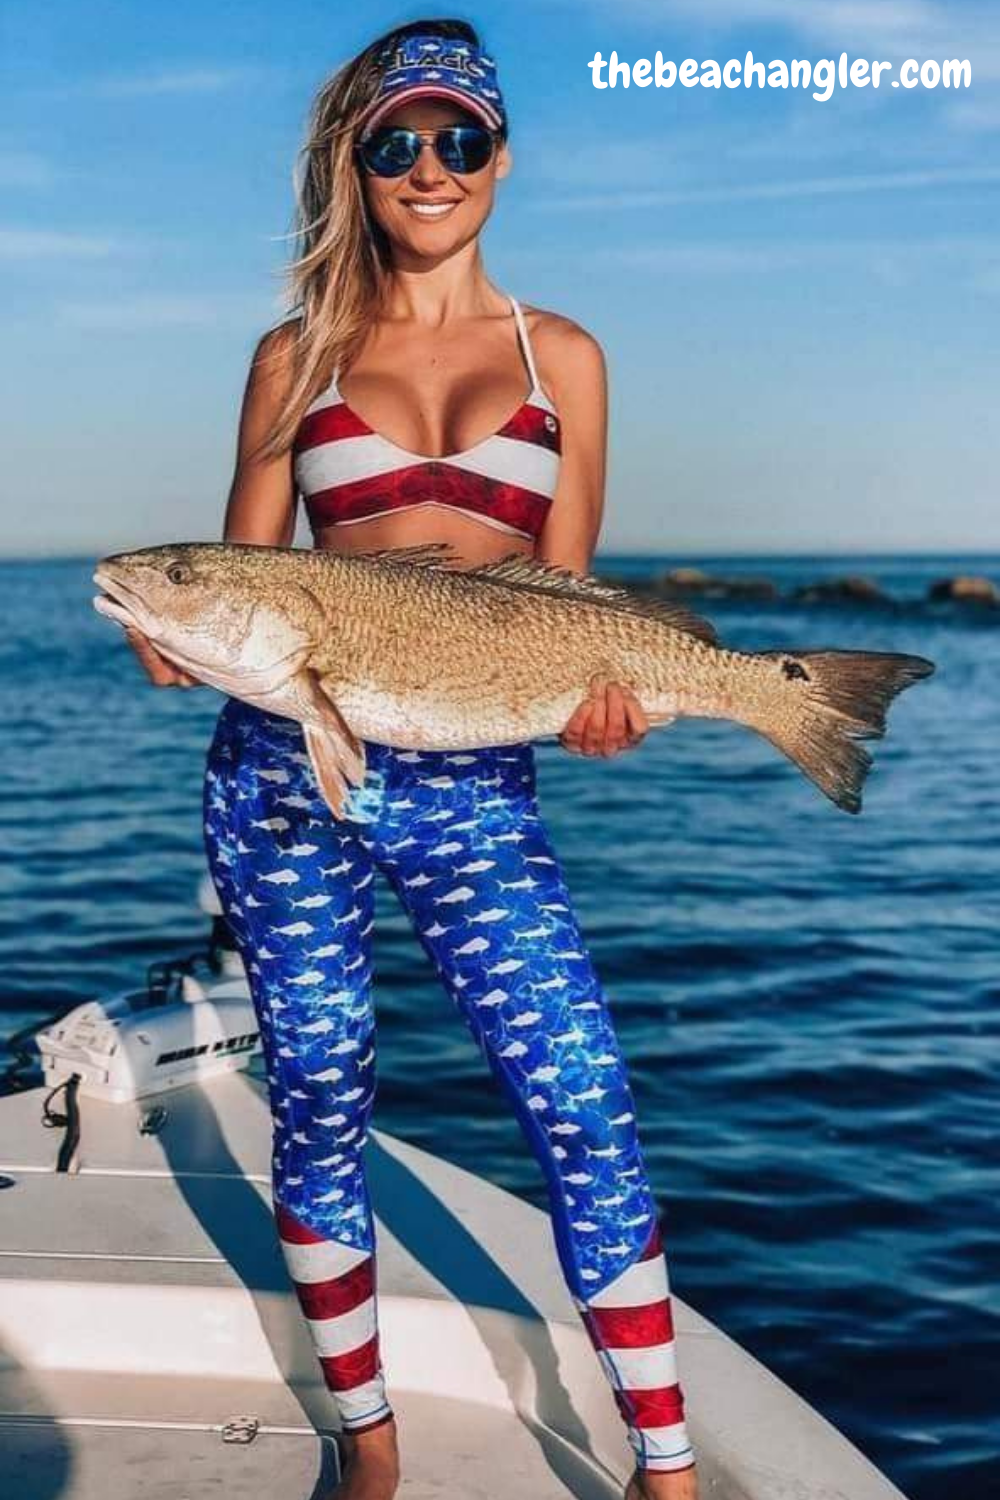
[274,1203,393,1433]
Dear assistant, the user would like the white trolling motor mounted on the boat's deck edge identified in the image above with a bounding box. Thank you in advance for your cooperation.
[28,876,261,1103]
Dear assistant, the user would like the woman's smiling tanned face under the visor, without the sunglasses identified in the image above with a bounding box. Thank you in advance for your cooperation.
[358,99,511,260]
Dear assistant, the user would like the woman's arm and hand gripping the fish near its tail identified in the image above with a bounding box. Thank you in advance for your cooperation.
[537,318,649,756]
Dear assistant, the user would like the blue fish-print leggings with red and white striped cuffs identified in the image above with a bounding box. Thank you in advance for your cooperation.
[204,699,694,1470]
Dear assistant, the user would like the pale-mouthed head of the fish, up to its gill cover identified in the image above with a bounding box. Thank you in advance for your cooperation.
[93,542,322,699]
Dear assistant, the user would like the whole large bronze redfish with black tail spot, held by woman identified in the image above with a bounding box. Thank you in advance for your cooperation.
[94,543,934,816]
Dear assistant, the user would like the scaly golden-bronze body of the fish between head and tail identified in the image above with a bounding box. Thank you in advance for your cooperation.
[301,543,722,750]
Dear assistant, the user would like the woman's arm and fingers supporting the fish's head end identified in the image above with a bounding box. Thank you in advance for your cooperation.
[124,321,295,687]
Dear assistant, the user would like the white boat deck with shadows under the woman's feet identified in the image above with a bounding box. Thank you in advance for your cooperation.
[0,1073,900,1500]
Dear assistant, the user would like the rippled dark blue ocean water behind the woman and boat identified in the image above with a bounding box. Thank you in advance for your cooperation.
[0,557,1000,1500]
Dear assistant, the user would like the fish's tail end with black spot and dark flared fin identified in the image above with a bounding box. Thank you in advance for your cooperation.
[741,648,934,813]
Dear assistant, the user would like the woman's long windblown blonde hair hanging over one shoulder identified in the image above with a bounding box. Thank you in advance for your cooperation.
[254,18,505,456]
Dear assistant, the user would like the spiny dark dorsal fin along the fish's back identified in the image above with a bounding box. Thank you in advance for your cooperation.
[355,542,718,645]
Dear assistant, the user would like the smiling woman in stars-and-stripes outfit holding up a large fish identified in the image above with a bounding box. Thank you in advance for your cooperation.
[125,21,696,1500]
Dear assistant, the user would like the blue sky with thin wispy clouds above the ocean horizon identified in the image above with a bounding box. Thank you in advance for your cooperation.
[0,0,1000,555]
